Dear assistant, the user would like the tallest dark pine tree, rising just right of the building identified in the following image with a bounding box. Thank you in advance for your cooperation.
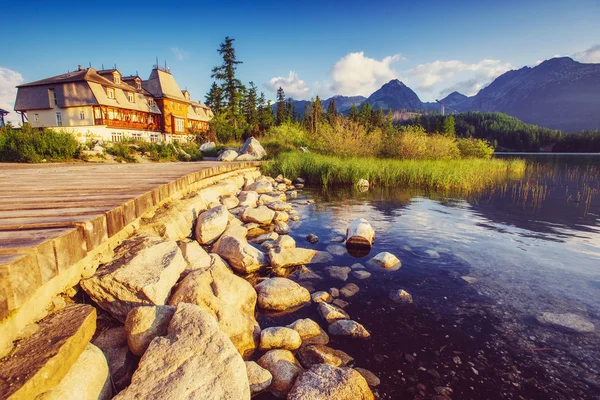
[211,36,242,128]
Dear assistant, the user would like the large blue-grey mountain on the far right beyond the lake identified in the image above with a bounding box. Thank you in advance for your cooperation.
[455,57,600,132]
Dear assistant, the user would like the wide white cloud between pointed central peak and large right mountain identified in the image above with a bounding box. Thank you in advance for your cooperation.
[403,59,513,96]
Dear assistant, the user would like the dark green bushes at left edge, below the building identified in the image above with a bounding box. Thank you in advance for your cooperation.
[0,124,80,163]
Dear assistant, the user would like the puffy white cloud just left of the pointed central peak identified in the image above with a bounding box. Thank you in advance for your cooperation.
[331,51,403,96]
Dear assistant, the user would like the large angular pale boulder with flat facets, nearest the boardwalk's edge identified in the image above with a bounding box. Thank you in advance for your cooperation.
[80,236,187,321]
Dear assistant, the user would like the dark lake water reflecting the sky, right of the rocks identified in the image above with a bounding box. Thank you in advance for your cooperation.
[258,155,600,400]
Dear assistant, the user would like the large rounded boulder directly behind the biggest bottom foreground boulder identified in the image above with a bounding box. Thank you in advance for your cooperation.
[169,264,260,359]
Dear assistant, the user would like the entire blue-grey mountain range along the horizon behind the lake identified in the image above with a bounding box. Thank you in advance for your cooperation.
[282,57,600,132]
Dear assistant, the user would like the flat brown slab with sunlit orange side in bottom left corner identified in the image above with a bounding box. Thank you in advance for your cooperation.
[0,304,96,399]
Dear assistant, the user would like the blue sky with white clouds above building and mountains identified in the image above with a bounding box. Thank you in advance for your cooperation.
[0,0,600,121]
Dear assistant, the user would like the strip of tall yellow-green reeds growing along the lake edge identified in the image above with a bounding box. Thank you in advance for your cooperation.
[262,152,526,194]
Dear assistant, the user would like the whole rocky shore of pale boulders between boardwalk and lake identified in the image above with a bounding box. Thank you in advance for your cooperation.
[0,161,398,400]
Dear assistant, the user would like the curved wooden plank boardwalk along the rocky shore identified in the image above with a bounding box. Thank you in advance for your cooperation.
[0,161,258,319]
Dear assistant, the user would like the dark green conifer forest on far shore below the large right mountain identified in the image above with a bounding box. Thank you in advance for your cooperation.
[416,112,562,151]
